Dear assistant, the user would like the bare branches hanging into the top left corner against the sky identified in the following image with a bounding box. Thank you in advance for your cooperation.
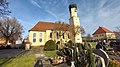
[0,0,11,17]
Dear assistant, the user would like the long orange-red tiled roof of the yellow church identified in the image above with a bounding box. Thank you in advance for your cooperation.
[29,21,67,31]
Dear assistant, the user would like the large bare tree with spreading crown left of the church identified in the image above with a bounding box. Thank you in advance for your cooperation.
[0,17,23,44]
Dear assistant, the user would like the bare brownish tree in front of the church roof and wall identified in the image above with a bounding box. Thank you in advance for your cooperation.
[54,21,69,45]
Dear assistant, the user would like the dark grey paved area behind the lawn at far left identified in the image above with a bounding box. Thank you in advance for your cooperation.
[0,49,23,58]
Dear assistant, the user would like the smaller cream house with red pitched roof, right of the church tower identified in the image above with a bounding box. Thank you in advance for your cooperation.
[93,26,116,40]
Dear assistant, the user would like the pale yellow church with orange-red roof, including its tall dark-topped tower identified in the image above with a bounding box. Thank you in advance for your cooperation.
[29,4,82,46]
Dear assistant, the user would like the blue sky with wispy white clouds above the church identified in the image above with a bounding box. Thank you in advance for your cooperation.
[8,0,120,36]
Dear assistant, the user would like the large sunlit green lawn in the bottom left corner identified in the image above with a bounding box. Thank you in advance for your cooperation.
[0,51,35,67]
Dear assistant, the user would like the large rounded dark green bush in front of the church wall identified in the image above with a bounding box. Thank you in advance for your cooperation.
[44,40,57,51]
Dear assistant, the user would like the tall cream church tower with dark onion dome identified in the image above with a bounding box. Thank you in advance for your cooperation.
[69,4,82,43]
